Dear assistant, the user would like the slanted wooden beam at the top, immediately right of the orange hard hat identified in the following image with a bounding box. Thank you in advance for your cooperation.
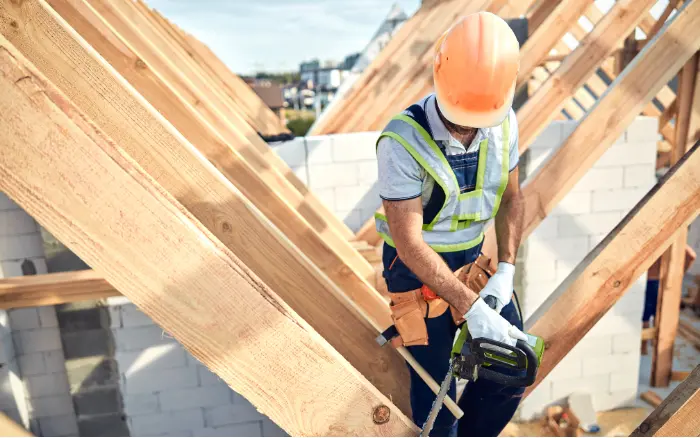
[517,0,593,89]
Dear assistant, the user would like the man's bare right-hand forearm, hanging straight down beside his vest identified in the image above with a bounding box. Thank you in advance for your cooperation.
[495,167,525,265]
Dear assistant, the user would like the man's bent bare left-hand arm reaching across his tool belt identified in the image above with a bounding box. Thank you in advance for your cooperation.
[383,197,479,315]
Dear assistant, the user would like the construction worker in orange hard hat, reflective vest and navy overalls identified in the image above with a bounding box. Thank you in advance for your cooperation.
[376,12,525,436]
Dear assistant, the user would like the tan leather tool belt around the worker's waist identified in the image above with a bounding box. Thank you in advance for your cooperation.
[377,254,494,347]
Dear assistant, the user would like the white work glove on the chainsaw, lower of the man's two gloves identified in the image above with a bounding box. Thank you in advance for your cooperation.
[464,298,527,347]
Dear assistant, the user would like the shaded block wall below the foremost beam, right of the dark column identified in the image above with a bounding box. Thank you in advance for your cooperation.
[108,297,287,436]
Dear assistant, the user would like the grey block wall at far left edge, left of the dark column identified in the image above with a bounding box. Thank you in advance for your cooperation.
[0,193,78,436]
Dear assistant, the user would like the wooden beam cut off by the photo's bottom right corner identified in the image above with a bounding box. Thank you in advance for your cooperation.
[630,365,700,437]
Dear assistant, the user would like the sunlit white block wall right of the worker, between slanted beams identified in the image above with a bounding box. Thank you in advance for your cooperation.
[518,117,657,419]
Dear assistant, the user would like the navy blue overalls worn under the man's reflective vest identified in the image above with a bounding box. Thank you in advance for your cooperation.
[382,104,524,436]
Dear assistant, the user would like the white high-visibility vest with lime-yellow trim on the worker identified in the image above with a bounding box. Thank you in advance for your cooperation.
[375,105,510,252]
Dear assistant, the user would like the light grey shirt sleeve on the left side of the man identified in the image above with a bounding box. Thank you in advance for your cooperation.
[377,137,423,201]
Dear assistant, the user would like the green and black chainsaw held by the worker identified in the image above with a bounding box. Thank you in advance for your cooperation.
[420,296,544,436]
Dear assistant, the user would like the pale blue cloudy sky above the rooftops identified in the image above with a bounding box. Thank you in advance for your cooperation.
[139,0,420,74]
